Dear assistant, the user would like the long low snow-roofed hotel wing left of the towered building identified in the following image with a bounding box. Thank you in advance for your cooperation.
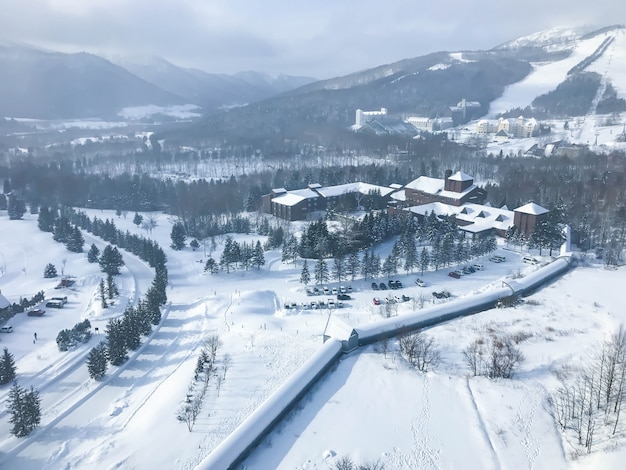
[261,182,397,221]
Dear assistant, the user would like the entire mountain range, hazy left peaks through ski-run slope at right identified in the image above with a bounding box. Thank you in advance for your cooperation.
[0,25,626,135]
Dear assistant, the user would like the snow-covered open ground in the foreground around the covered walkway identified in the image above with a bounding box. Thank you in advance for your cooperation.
[0,211,626,470]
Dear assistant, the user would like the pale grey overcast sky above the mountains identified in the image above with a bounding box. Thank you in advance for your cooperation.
[0,0,626,79]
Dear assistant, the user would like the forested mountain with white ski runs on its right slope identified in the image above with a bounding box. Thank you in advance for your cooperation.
[189,25,626,140]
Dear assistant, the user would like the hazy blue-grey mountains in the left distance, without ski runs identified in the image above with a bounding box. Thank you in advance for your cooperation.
[0,45,314,119]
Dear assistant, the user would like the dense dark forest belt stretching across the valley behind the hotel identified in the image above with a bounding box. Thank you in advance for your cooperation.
[0,135,626,260]
